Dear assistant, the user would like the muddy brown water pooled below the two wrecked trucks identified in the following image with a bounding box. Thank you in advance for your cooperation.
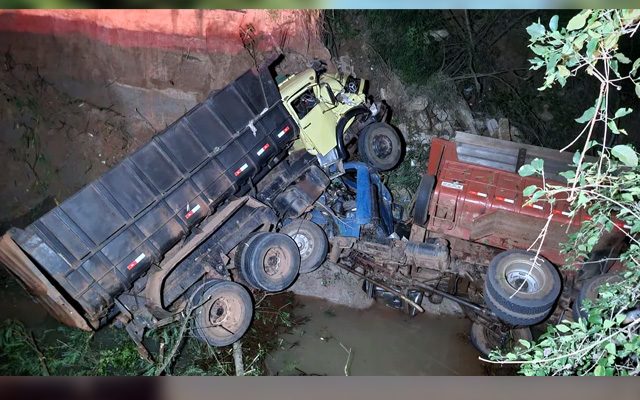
[267,297,484,375]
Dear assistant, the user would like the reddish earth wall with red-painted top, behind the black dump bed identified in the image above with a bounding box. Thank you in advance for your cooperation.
[0,10,329,228]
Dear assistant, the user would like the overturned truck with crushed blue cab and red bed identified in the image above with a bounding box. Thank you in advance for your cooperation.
[311,132,637,354]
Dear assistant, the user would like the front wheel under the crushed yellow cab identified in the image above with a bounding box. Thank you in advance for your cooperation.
[358,122,402,171]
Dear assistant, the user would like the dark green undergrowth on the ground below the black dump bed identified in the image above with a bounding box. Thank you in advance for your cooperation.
[0,295,296,376]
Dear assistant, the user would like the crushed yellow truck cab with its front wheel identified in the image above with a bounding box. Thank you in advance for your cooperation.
[278,68,403,176]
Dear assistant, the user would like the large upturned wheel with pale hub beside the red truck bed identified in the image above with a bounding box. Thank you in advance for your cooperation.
[485,250,562,315]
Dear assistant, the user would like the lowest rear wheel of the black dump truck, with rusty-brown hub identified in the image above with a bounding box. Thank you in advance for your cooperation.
[192,281,253,347]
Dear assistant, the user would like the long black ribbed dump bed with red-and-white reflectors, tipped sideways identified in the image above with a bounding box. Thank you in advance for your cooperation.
[11,69,298,327]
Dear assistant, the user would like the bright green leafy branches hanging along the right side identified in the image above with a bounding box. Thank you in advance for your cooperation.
[493,10,640,376]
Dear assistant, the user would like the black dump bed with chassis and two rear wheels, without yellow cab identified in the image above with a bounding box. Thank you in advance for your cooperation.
[0,63,338,351]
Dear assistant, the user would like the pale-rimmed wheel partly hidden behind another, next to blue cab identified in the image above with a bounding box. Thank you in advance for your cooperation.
[280,219,329,274]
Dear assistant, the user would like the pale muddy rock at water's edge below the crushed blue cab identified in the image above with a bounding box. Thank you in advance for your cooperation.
[291,263,373,309]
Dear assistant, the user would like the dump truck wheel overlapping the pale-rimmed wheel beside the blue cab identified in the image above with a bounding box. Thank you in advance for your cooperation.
[236,232,300,292]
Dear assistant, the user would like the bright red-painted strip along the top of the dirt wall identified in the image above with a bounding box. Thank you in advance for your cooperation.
[0,10,319,54]
